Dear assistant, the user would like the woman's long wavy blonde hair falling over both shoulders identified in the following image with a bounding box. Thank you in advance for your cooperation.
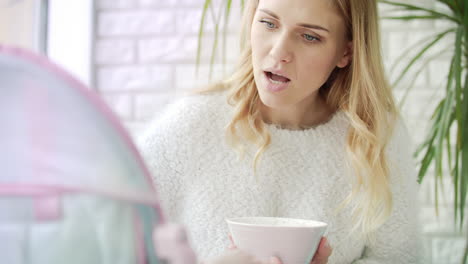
[205,0,398,235]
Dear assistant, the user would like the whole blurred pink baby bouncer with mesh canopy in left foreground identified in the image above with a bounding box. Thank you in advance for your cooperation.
[0,47,195,264]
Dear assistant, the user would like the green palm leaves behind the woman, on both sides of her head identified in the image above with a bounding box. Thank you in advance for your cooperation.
[197,0,468,263]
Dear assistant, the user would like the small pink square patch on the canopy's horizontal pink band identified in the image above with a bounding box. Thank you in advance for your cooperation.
[34,195,62,221]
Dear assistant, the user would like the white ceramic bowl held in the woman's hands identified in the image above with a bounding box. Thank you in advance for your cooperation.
[226,217,327,264]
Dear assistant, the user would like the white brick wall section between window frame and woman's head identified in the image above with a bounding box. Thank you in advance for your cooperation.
[94,0,240,131]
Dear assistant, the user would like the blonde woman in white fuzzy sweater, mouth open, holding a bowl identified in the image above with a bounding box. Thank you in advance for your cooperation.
[142,0,419,264]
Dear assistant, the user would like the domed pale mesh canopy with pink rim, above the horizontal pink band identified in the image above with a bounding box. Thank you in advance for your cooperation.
[0,48,157,203]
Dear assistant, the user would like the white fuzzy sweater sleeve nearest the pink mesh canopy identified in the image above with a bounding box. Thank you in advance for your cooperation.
[137,98,200,219]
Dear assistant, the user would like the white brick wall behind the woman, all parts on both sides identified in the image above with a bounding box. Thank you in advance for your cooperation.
[94,0,465,264]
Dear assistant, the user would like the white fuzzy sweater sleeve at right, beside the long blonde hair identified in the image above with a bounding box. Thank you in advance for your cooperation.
[353,121,423,264]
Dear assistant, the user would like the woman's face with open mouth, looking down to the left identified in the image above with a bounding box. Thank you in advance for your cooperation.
[251,0,351,109]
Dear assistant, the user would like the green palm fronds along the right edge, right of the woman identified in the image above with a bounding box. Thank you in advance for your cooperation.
[380,0,468,256]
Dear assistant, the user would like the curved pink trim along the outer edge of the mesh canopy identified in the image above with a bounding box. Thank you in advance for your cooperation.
[0,45,166,223]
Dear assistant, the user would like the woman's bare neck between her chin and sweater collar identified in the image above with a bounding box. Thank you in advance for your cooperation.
[260,93,334,130]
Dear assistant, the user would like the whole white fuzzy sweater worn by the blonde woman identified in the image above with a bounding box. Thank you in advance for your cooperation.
[139,93,420,264]
